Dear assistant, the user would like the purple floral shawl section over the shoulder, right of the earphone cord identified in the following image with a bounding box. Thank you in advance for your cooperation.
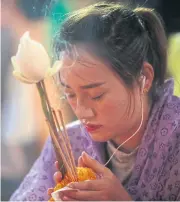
[126,80,180,201]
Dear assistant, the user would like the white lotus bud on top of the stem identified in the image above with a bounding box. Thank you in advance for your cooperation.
[11,32,61,83]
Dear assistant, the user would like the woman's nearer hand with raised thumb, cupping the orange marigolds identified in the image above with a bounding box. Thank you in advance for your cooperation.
[60,152,132,201]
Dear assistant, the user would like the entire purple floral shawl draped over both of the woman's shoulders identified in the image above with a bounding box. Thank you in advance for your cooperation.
[10,80,180,201]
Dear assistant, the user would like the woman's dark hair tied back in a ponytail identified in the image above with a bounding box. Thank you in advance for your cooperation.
[54,3,167,100]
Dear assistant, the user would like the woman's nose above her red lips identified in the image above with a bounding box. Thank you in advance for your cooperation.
[75,97,95,119]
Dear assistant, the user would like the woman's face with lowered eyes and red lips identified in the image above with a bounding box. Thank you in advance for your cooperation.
[60,49,141,142]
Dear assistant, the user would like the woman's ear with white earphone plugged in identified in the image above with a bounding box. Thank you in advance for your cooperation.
[142,62,154,92]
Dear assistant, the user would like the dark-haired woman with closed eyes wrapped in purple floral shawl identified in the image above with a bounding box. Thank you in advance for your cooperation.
[11,3,180,201]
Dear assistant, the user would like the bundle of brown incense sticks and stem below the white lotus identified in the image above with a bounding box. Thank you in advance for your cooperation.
[37,81,78,181]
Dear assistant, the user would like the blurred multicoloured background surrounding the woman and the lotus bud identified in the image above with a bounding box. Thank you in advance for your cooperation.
[1,0,180,201]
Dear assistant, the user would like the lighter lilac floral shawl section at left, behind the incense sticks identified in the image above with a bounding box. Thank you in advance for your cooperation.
[10,121,105,201]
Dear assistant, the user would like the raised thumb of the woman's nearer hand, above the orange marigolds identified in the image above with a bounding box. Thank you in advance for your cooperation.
[82,152,112,176]
